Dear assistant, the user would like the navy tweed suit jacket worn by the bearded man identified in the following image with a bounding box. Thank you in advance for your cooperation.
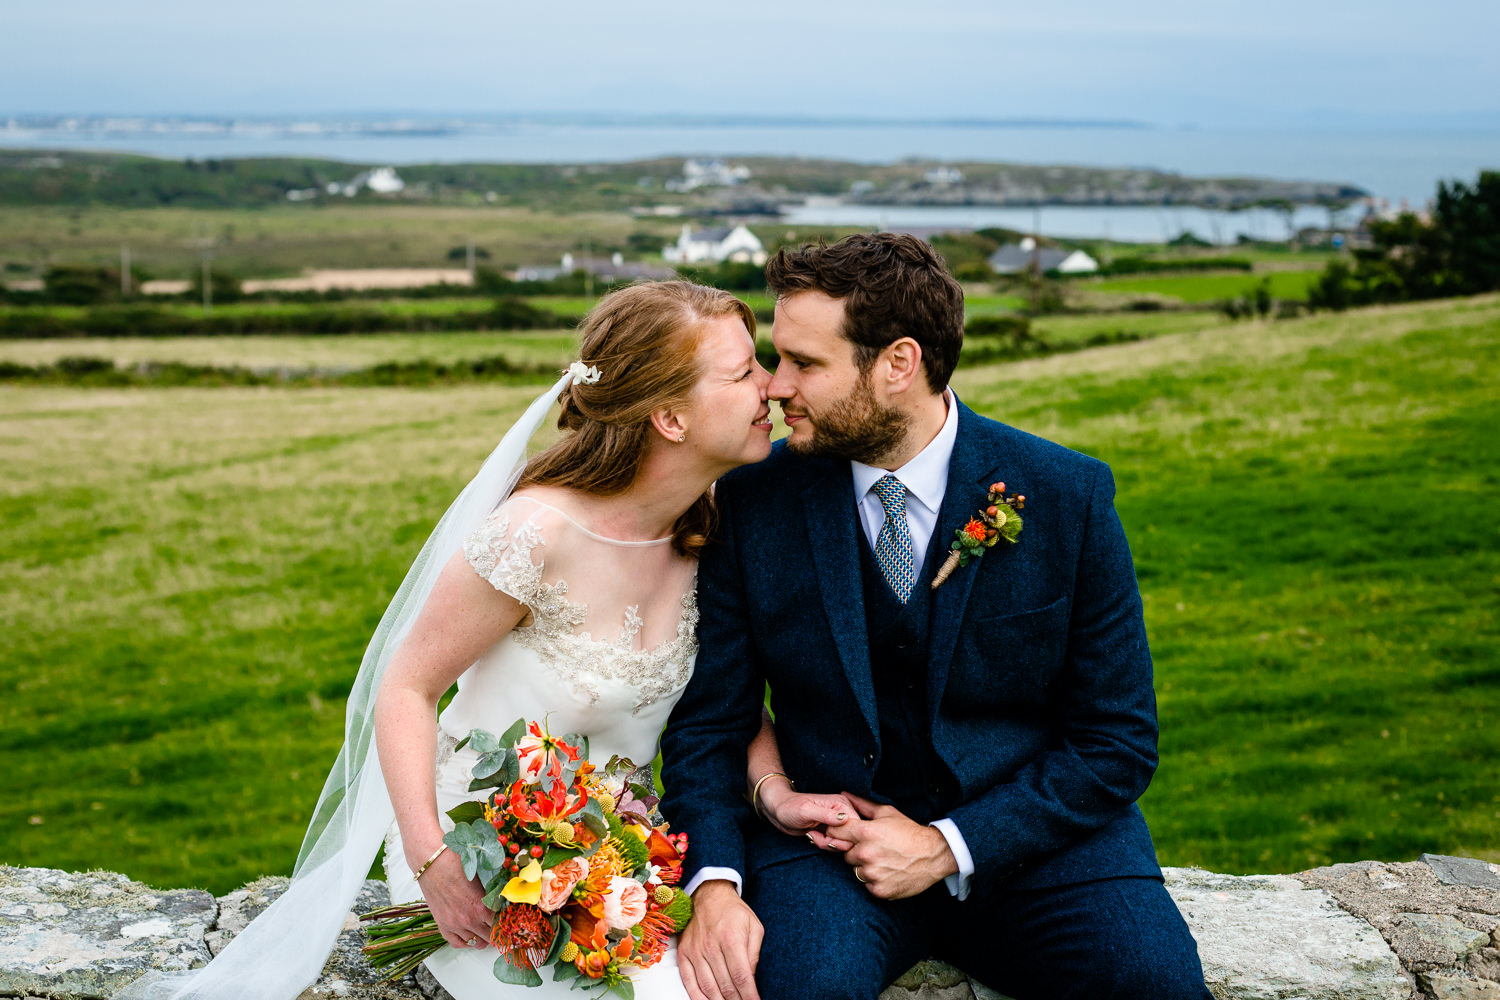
[662,403,1161,900]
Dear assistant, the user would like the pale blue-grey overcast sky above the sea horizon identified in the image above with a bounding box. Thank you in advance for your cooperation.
[0,0,1500,127]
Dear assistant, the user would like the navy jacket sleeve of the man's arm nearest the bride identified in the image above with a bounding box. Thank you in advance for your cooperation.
[662,483,765,885]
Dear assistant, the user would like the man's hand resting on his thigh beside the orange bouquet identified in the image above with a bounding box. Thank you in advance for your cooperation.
[677,879,765,1000]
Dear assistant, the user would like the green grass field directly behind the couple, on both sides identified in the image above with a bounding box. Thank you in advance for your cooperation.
[0,297,1500,892]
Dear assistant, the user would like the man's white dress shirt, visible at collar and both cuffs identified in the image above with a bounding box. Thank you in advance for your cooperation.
[686,390,974,900]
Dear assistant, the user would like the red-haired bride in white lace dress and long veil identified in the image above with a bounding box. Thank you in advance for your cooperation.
[119,282,798,1000]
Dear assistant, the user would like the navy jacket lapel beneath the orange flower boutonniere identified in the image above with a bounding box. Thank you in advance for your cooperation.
[923,403,1001,714]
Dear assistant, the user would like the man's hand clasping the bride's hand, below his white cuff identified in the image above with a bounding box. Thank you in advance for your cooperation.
[828,792,959,900]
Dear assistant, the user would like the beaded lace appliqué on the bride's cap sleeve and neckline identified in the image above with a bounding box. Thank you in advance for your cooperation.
[464,514,698,714]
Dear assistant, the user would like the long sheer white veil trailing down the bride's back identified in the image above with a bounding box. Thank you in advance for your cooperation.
[114,361,599,1000]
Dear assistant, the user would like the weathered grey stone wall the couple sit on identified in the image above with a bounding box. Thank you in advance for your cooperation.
[0,855,1500,1000]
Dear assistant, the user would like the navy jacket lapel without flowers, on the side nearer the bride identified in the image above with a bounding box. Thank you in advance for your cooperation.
[801,462,881,733]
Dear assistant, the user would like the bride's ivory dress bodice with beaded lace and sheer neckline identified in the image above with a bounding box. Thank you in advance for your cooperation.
[441,496,698,763]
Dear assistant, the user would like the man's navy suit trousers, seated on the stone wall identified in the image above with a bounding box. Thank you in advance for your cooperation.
[746,853,1212,1000]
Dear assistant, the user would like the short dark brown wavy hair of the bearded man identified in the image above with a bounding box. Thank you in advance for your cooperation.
[765,232,963,393]
